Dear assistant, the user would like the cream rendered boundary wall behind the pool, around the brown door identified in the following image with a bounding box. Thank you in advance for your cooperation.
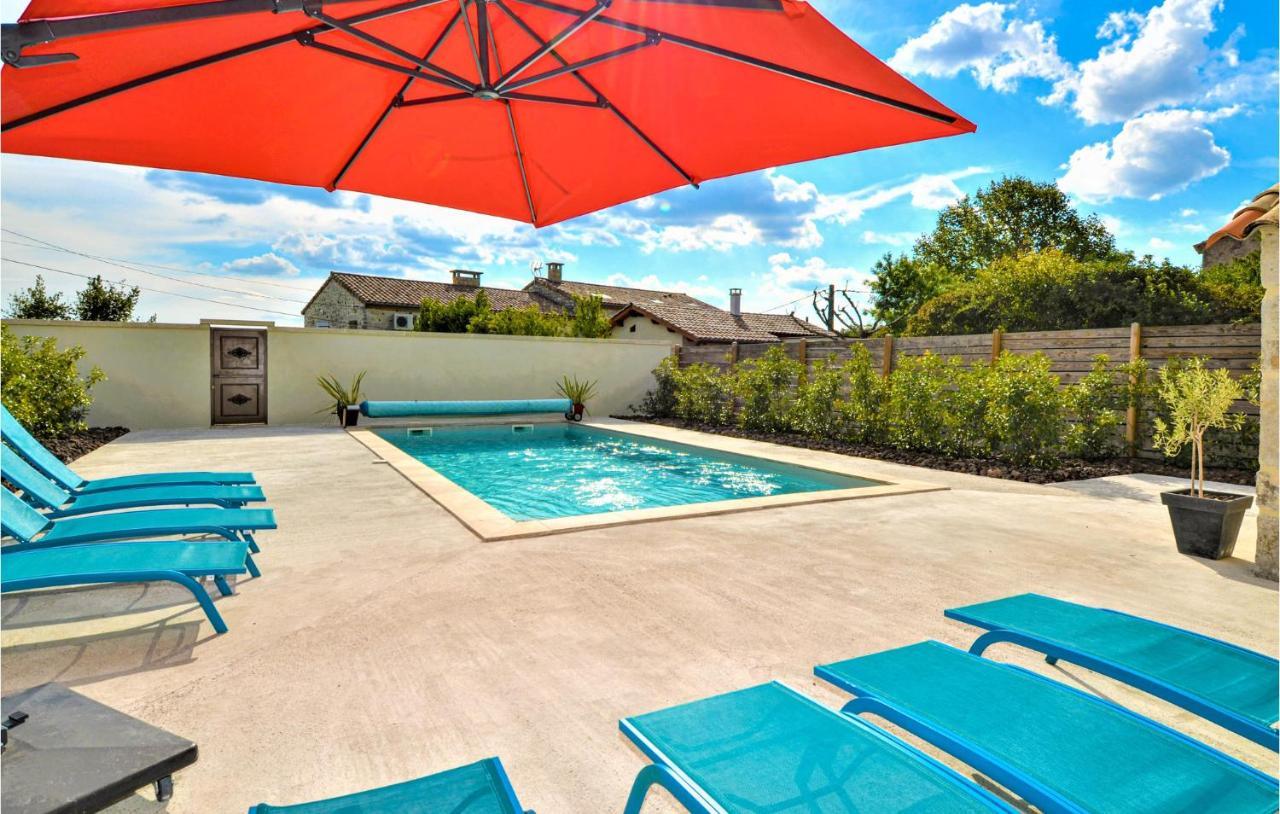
[4,320,672,430]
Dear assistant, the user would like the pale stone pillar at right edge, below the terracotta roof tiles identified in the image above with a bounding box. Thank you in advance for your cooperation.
[1254,224,1280,580]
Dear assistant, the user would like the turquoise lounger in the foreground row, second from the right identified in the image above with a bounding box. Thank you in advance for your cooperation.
[814,641,1280,814]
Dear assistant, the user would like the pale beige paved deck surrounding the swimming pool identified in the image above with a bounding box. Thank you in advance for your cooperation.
[0,427,1277,814]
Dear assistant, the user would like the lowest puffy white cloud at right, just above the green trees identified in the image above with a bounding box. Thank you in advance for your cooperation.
[1057,108,1238,204]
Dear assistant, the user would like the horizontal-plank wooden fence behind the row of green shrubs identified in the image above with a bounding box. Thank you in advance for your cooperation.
[680,323,1262,462]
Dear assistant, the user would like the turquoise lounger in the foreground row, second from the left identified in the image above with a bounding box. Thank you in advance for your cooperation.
[618,683,1011,814]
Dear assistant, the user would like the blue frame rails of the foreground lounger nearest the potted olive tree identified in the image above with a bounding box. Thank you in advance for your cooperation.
[943,608,1280,751]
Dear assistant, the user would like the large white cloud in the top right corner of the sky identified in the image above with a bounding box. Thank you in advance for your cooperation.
[1043,0,1276,124]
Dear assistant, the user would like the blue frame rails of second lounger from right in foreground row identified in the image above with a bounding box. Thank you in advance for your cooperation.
[813,652,1280,814]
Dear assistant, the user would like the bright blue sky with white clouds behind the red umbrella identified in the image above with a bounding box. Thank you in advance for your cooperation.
[0,0,1277,324]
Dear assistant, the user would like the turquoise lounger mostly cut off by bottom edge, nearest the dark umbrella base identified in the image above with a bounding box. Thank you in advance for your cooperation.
[248,758,534,814]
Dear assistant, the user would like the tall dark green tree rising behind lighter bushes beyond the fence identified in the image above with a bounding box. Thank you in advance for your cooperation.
[872,175,1116,328]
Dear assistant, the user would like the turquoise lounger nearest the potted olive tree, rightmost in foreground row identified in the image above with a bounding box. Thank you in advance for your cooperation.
[946,594,1280,751]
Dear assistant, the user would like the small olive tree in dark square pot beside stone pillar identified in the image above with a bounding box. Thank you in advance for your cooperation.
[1155,357,1253,559]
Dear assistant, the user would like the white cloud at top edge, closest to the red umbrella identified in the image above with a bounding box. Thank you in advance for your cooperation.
[890,3,1070,93]
